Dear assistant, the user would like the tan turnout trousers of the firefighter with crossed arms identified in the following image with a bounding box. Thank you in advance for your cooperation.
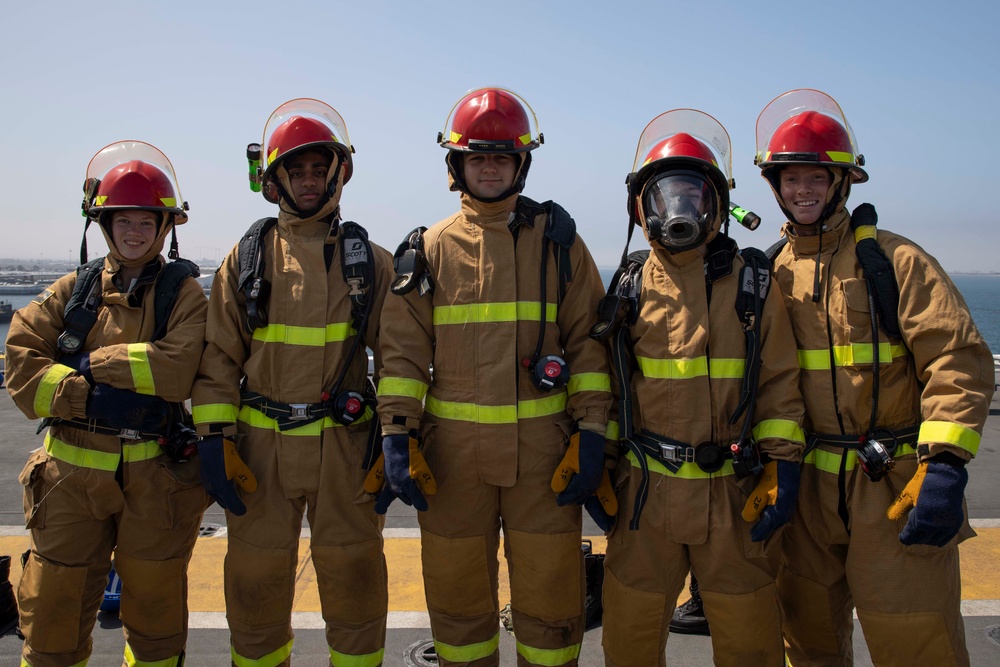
[17,444,210,667]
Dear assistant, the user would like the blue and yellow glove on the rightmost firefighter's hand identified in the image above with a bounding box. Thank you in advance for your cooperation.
[886,460,969,547]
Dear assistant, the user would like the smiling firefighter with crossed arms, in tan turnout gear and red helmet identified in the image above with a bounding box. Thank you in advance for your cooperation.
[7,141,211,667]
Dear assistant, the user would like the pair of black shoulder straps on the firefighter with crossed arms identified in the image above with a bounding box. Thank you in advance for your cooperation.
[58,257,201,354]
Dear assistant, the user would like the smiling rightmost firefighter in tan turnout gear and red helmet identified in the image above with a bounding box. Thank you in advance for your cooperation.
[756,89,993,667]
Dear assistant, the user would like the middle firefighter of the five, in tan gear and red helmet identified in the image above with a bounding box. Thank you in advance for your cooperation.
[378,88,611,667]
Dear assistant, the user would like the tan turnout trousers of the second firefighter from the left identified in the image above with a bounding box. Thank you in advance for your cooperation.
[225,420,388,667]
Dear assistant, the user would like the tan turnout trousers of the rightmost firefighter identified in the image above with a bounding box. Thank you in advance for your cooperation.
[776,448,975,667]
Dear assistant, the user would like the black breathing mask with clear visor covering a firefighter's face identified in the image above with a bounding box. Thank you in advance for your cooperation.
[640,170,719,251]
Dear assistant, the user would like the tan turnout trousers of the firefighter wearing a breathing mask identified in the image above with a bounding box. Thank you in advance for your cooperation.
[603,454,784,667]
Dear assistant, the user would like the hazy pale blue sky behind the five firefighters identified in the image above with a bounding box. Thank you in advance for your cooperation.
[0,0,1000,271]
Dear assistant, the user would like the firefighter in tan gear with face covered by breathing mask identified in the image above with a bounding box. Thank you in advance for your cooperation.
[595,109,805,667]
